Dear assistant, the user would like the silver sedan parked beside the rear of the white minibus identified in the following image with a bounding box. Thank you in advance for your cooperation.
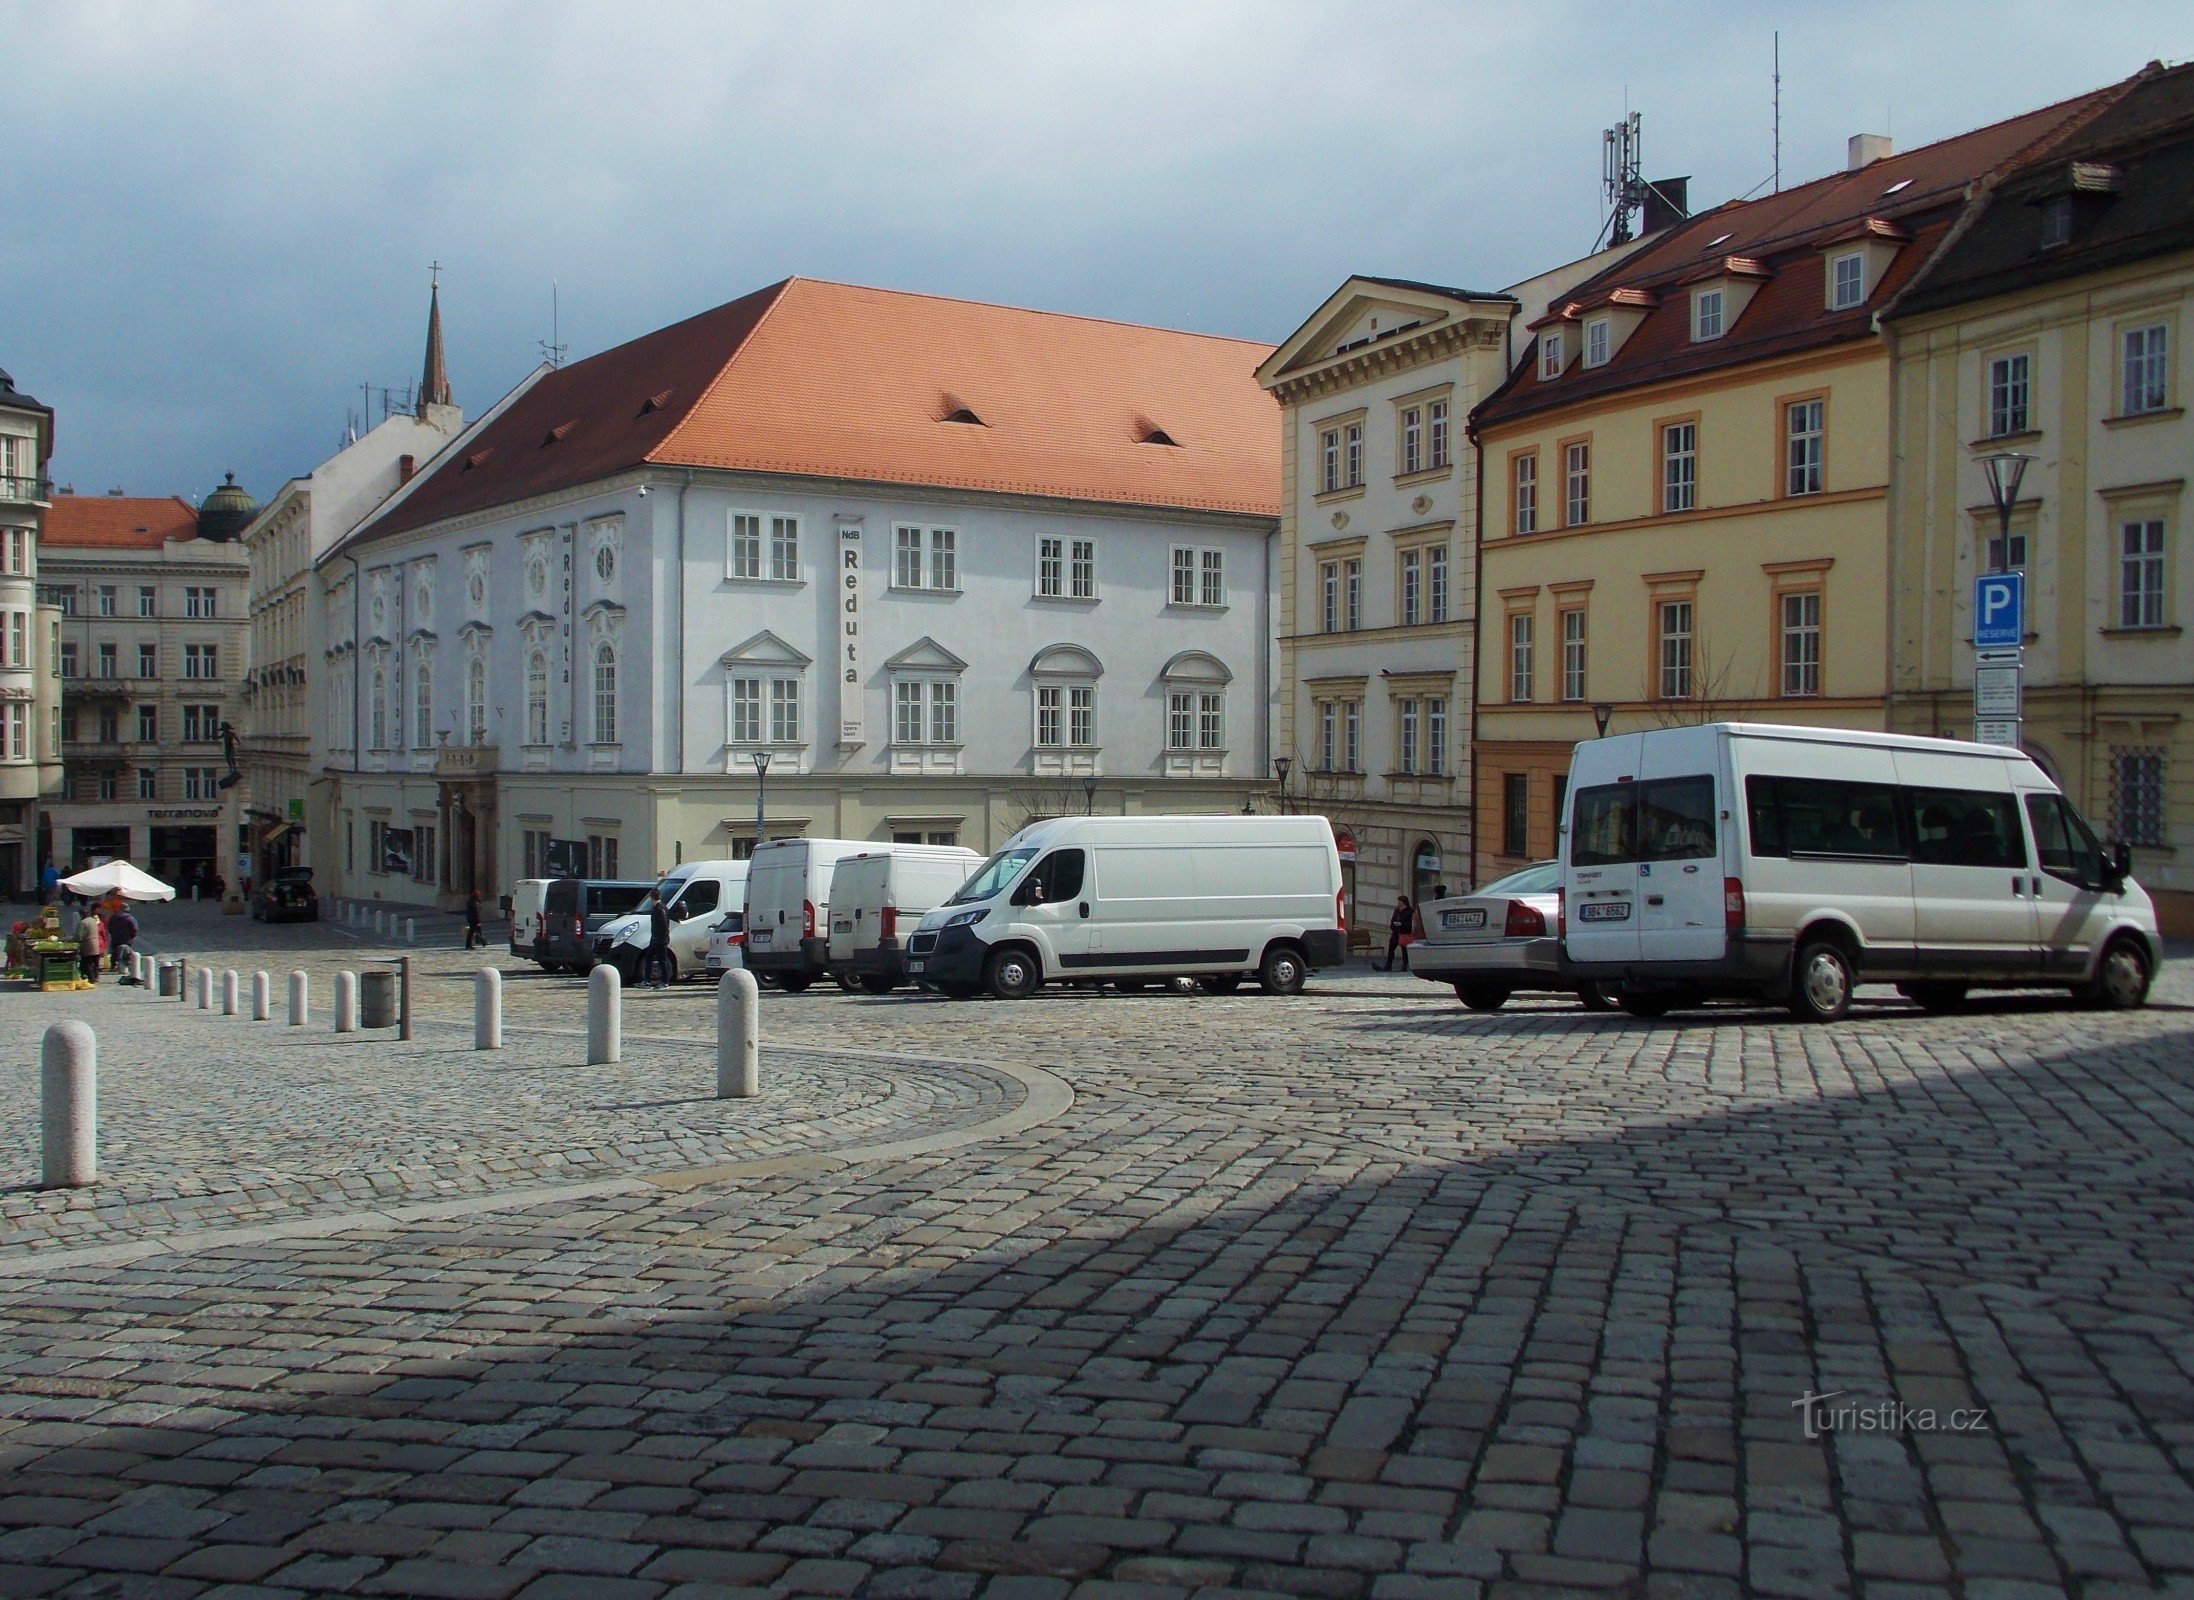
[1409,860,1613,1012]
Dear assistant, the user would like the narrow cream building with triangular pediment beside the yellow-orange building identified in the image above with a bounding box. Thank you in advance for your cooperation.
[1257,277,1516,931]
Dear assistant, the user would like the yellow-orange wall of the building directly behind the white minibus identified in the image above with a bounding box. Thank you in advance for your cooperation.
[1474,342,1889,878]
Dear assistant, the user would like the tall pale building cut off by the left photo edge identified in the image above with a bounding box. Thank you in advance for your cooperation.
[0,373,61,900]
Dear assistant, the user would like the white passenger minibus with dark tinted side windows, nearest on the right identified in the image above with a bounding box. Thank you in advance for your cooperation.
[1562,722,2161,1021]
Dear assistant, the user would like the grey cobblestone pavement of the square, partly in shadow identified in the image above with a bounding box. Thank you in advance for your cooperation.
[0,904,2194,1600]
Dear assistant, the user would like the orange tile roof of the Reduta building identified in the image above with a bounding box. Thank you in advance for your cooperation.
[369,279,1279,536]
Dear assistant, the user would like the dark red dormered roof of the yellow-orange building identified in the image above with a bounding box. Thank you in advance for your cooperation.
[1472,83,2124,428]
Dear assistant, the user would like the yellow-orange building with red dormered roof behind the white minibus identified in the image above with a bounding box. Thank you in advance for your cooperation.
[1472,97,2097,882]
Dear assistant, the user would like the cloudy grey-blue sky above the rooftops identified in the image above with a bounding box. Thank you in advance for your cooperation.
[0,0,2194,498]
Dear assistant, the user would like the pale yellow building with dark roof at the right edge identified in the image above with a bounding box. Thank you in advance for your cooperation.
[1885,68,2194,935]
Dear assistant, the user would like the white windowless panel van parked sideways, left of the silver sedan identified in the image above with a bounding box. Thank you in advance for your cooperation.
[906,816,1347,999]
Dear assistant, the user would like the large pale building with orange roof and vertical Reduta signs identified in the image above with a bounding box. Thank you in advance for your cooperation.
[316,279,1279,906]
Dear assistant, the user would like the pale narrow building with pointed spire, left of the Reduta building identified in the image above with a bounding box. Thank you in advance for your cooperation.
[239,290,463,874]
